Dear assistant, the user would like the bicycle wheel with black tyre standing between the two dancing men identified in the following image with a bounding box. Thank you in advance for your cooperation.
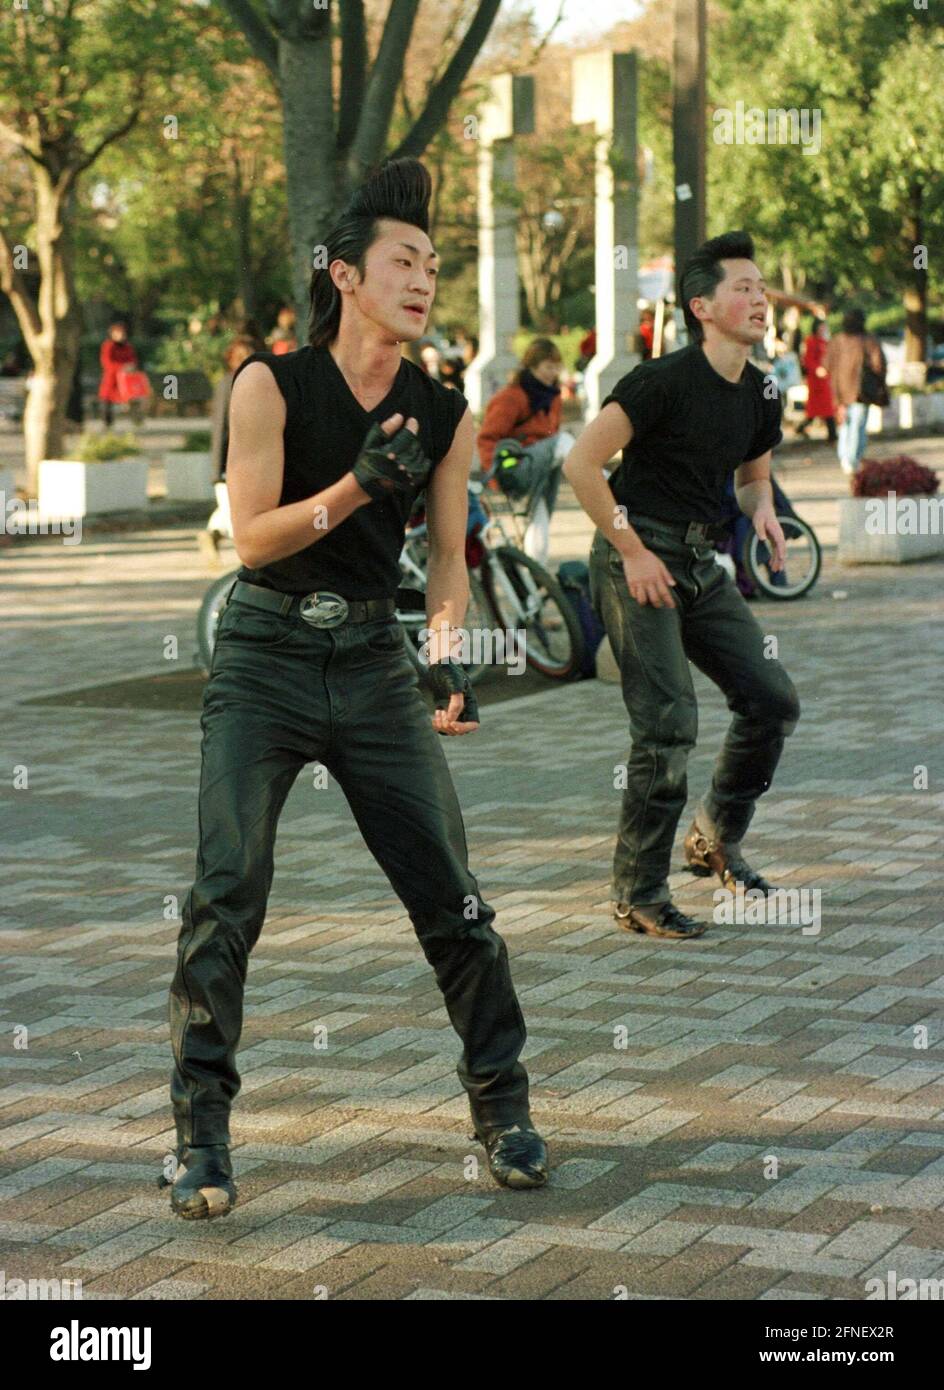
[482,545,584,681]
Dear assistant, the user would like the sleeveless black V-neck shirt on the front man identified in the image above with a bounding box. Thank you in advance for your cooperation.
[232,346,469,599]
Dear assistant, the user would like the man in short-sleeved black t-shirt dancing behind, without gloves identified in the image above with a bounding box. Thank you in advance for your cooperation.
[564,232,799,940]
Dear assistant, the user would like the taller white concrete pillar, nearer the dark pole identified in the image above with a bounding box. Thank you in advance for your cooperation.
[571,51,640,420]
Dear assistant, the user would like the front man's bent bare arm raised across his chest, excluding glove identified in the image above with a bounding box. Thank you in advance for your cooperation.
[227,361,372,570]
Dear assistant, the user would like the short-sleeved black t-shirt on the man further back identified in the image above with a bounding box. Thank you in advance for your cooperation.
[601,343,783,521]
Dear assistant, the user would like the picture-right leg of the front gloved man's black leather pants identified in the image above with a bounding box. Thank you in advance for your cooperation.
[327,628,530,1133]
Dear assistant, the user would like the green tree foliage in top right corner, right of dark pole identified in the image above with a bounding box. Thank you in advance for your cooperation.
[708,0,944,356]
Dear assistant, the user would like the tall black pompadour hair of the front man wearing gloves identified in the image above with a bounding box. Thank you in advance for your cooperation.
[309,158,432,348]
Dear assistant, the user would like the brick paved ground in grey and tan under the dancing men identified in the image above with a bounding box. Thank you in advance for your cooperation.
[0,441,944,1300]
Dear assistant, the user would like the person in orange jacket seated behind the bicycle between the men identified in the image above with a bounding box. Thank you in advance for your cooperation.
[478,338,574,564]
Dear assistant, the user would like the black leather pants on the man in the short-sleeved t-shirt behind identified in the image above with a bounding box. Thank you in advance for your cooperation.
[589,517,799,905]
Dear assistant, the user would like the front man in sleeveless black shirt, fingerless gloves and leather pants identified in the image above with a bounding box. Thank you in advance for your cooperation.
[165,158,548,1219]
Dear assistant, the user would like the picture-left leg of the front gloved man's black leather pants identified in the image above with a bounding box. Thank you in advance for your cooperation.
[170,603,327,1144]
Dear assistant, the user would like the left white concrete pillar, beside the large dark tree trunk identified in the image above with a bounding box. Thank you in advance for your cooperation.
[463,72,534,411]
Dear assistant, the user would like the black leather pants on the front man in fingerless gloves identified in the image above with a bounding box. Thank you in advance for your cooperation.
[170,602,530,1144]
